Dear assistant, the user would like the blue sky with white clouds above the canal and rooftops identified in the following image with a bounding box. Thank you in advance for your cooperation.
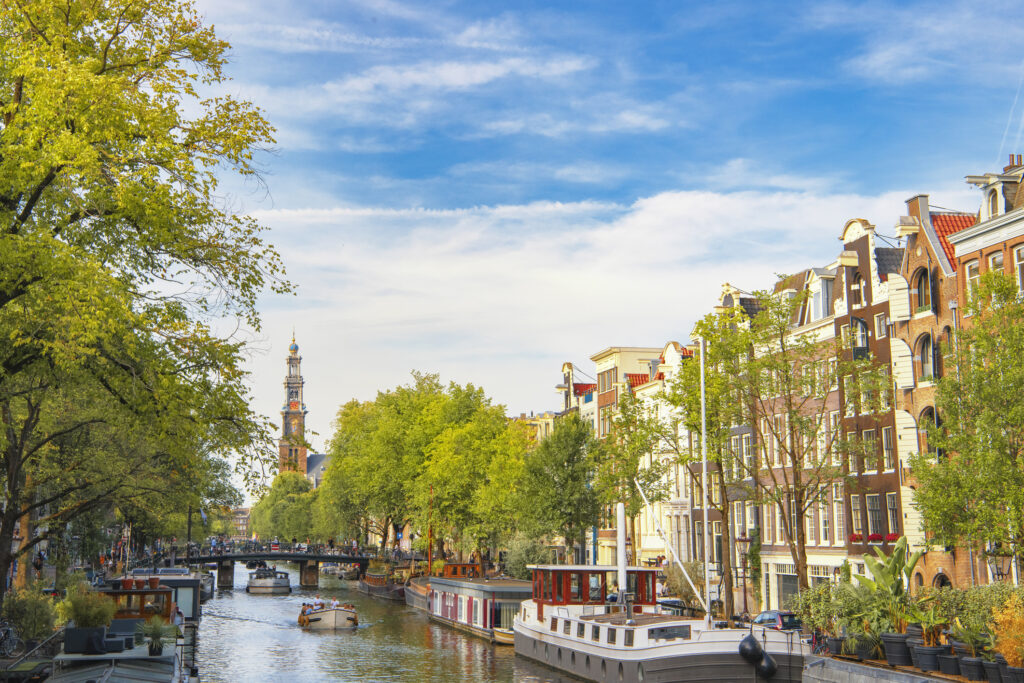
[188,0,1024,456]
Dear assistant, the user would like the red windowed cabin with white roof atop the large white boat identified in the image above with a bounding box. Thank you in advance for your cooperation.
[528,564,657,618]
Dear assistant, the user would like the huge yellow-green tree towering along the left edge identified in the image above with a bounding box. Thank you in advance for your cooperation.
[0,0,289,598]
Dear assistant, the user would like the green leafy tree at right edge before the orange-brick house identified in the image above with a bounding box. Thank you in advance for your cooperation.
[910,273,1024,557]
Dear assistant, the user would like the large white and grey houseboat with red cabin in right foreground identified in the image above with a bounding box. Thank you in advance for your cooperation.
[514,565,809,683]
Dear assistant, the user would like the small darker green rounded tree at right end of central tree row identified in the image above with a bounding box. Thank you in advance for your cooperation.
[521,413,601,565]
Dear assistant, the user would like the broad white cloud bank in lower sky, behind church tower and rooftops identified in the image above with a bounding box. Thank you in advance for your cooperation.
[241,183,970,443]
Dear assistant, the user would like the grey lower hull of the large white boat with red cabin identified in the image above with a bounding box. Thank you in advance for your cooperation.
[514,631,804,683]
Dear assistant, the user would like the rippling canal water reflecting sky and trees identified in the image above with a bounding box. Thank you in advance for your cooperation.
[196,564,578,683]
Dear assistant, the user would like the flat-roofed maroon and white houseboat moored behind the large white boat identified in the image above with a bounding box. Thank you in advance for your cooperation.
[429,577,531,644]
